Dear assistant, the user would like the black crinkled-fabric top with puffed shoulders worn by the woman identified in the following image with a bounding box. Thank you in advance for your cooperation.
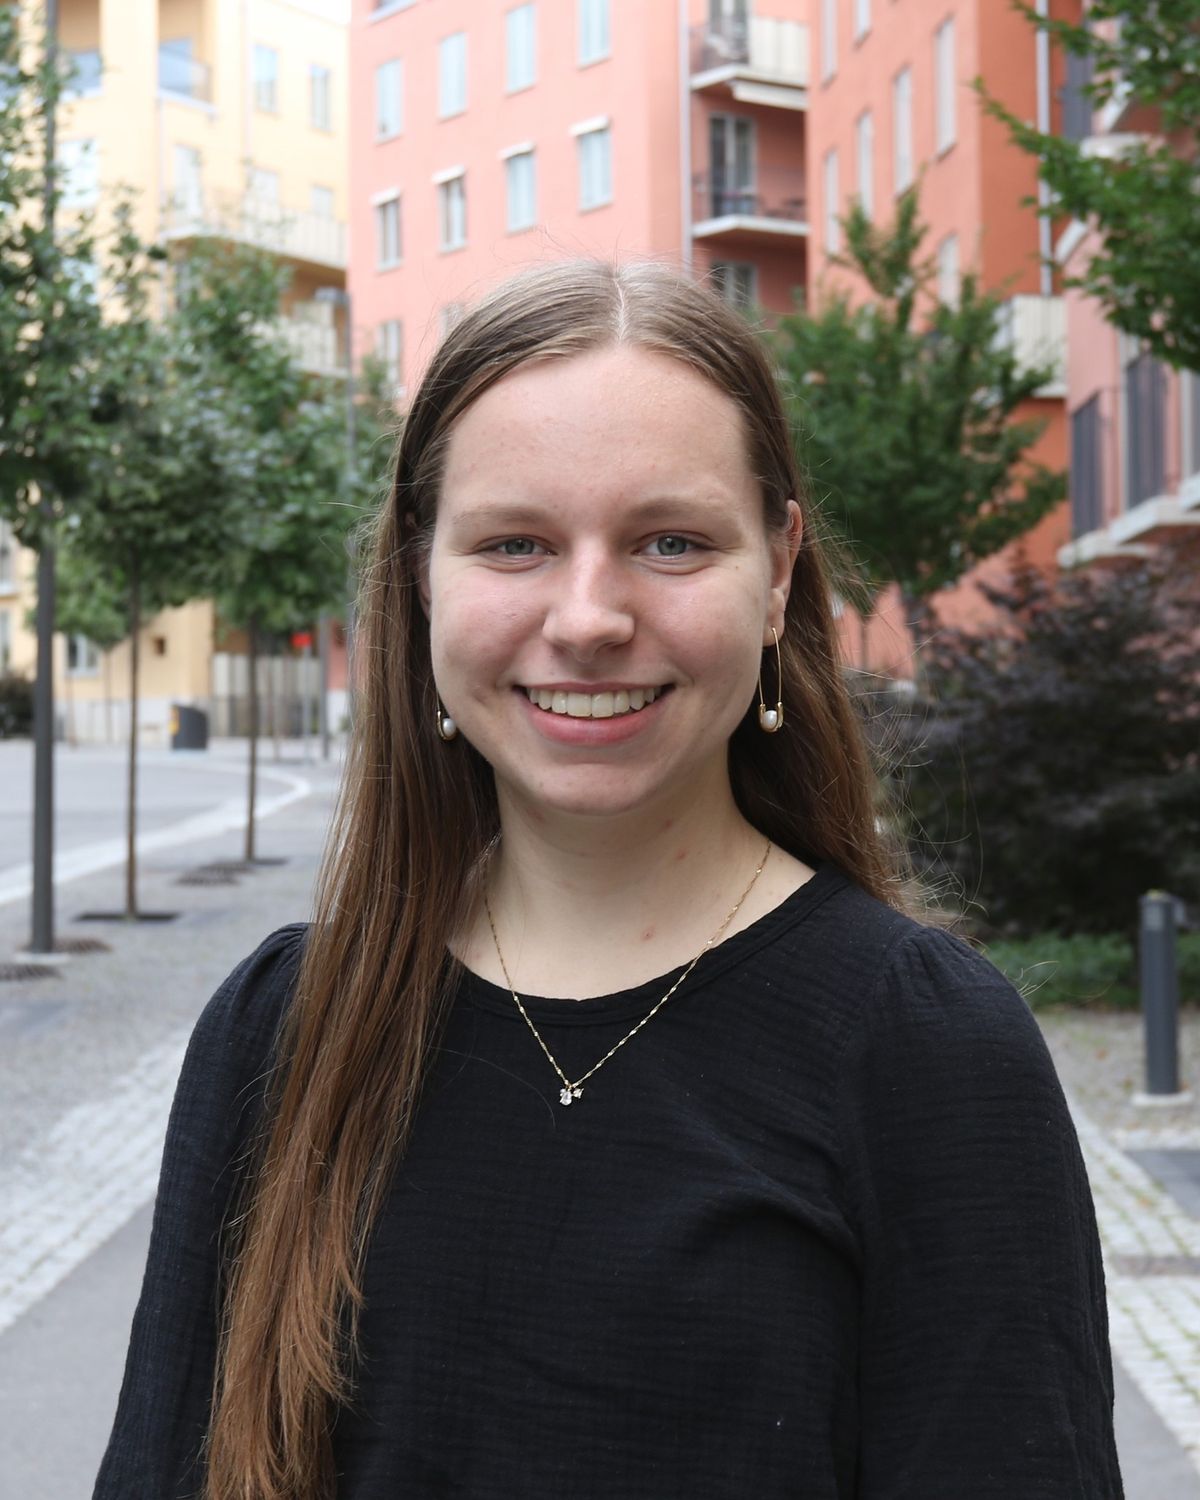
[95,867,1122,1500]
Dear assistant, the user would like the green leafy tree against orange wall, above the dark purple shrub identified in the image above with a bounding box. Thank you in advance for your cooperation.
[773,191,1067,641]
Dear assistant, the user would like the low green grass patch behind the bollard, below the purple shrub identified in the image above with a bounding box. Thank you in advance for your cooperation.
[984,933,1200,1011]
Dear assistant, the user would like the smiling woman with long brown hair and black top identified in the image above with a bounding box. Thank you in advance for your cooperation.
[96,263,1121,1500]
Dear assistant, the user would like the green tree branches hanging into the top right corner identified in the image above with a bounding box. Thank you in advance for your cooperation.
[975,0,1200,371]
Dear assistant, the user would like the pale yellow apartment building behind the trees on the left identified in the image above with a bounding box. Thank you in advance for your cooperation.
[0,0,350,744]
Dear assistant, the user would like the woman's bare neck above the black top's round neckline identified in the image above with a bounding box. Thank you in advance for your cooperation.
[461,792,812,999]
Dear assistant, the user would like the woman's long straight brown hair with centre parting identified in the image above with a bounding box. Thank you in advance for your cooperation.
[206,261,903,1500]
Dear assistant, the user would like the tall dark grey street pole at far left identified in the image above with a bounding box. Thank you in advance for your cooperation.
[30,0,59,953]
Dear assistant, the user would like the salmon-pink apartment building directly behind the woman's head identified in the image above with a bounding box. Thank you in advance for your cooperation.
[350,0,810,389]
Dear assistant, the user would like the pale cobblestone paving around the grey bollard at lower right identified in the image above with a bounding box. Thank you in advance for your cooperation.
[1040,1016,1200,1472]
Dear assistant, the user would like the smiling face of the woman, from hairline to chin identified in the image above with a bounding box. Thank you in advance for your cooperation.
[425,347,800,818]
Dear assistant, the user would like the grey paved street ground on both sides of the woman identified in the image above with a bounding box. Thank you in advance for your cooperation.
[0,746,1200,1500]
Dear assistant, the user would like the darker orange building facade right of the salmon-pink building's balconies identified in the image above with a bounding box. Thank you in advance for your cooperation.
[809,0,1080,677]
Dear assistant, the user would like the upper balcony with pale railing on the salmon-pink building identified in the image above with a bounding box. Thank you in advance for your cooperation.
[692,17,809,110]
